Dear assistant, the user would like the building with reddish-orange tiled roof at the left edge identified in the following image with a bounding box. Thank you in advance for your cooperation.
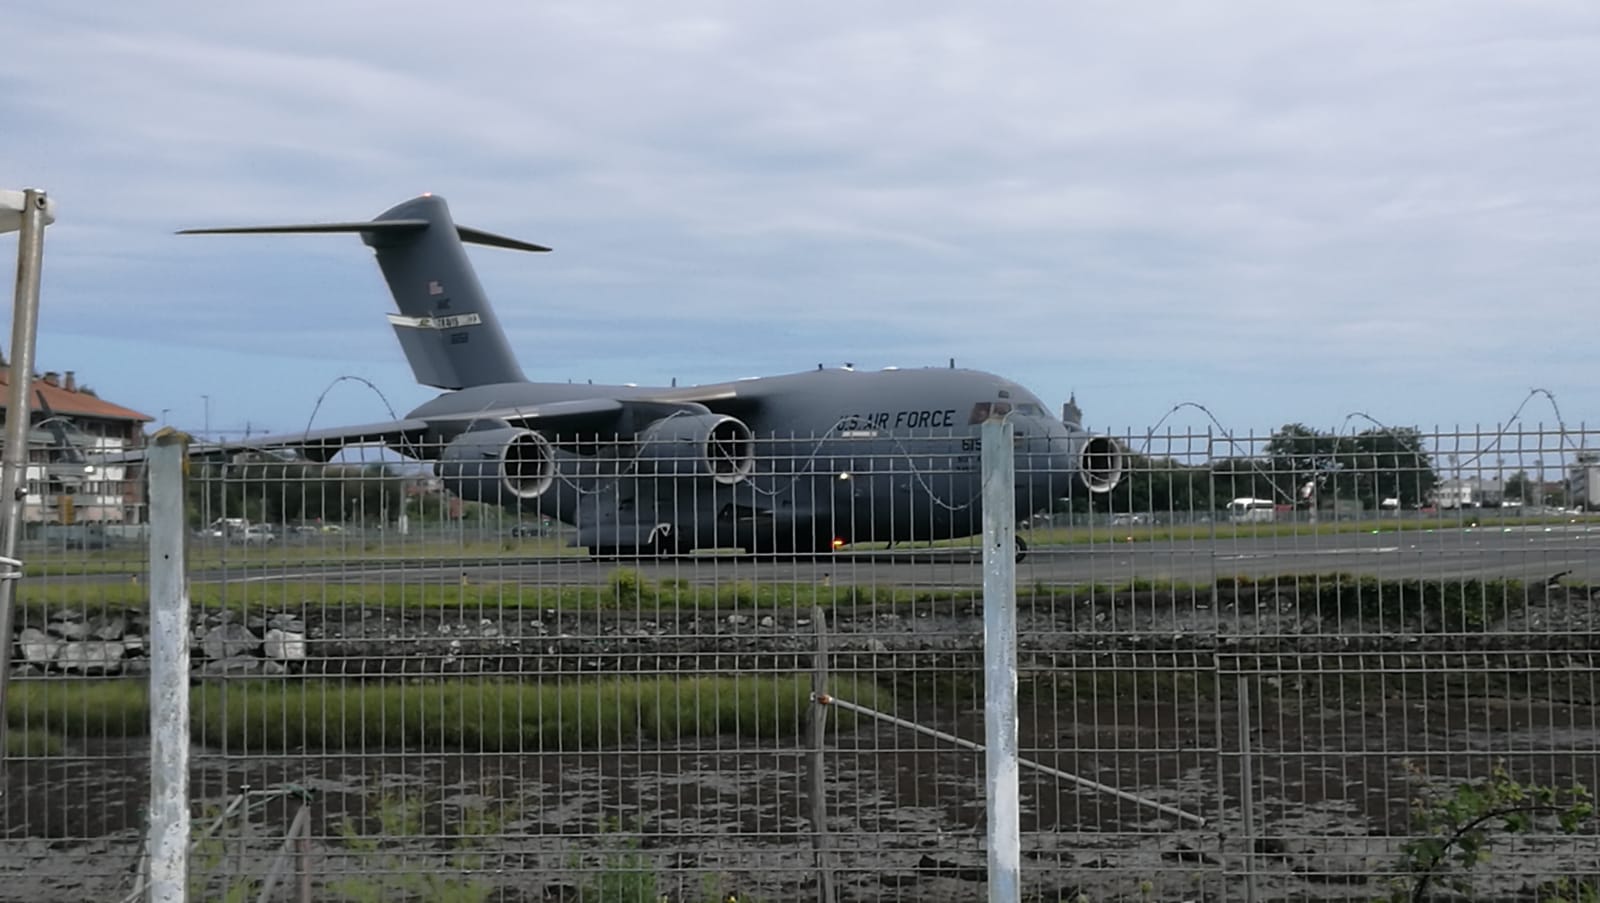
[0,367,155,524]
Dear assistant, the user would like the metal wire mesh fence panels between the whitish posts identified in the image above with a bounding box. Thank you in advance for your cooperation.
[0,429,1600,903]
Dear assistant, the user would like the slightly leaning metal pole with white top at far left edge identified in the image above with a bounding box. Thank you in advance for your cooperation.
[0,189,56,768]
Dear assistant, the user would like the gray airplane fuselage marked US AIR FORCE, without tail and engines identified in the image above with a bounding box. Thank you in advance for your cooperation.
[408,368,1088,551]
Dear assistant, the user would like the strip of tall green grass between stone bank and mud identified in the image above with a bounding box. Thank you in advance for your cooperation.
[6,676,878,754]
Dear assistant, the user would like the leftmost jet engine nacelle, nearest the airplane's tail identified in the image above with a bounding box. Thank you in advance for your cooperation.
[438,427,555,504]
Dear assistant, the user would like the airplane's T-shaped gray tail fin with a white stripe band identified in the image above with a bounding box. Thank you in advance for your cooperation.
[179,194,550,389]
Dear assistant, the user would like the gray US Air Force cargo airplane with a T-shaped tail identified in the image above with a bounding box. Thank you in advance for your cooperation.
[131,194,1123,556]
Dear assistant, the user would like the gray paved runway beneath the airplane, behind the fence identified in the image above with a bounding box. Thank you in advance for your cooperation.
[192,525,1600,586]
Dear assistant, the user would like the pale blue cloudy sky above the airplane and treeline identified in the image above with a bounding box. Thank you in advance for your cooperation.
[0,0,1600,448]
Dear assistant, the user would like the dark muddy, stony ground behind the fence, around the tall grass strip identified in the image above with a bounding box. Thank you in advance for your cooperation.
[0,594,1600,903]
